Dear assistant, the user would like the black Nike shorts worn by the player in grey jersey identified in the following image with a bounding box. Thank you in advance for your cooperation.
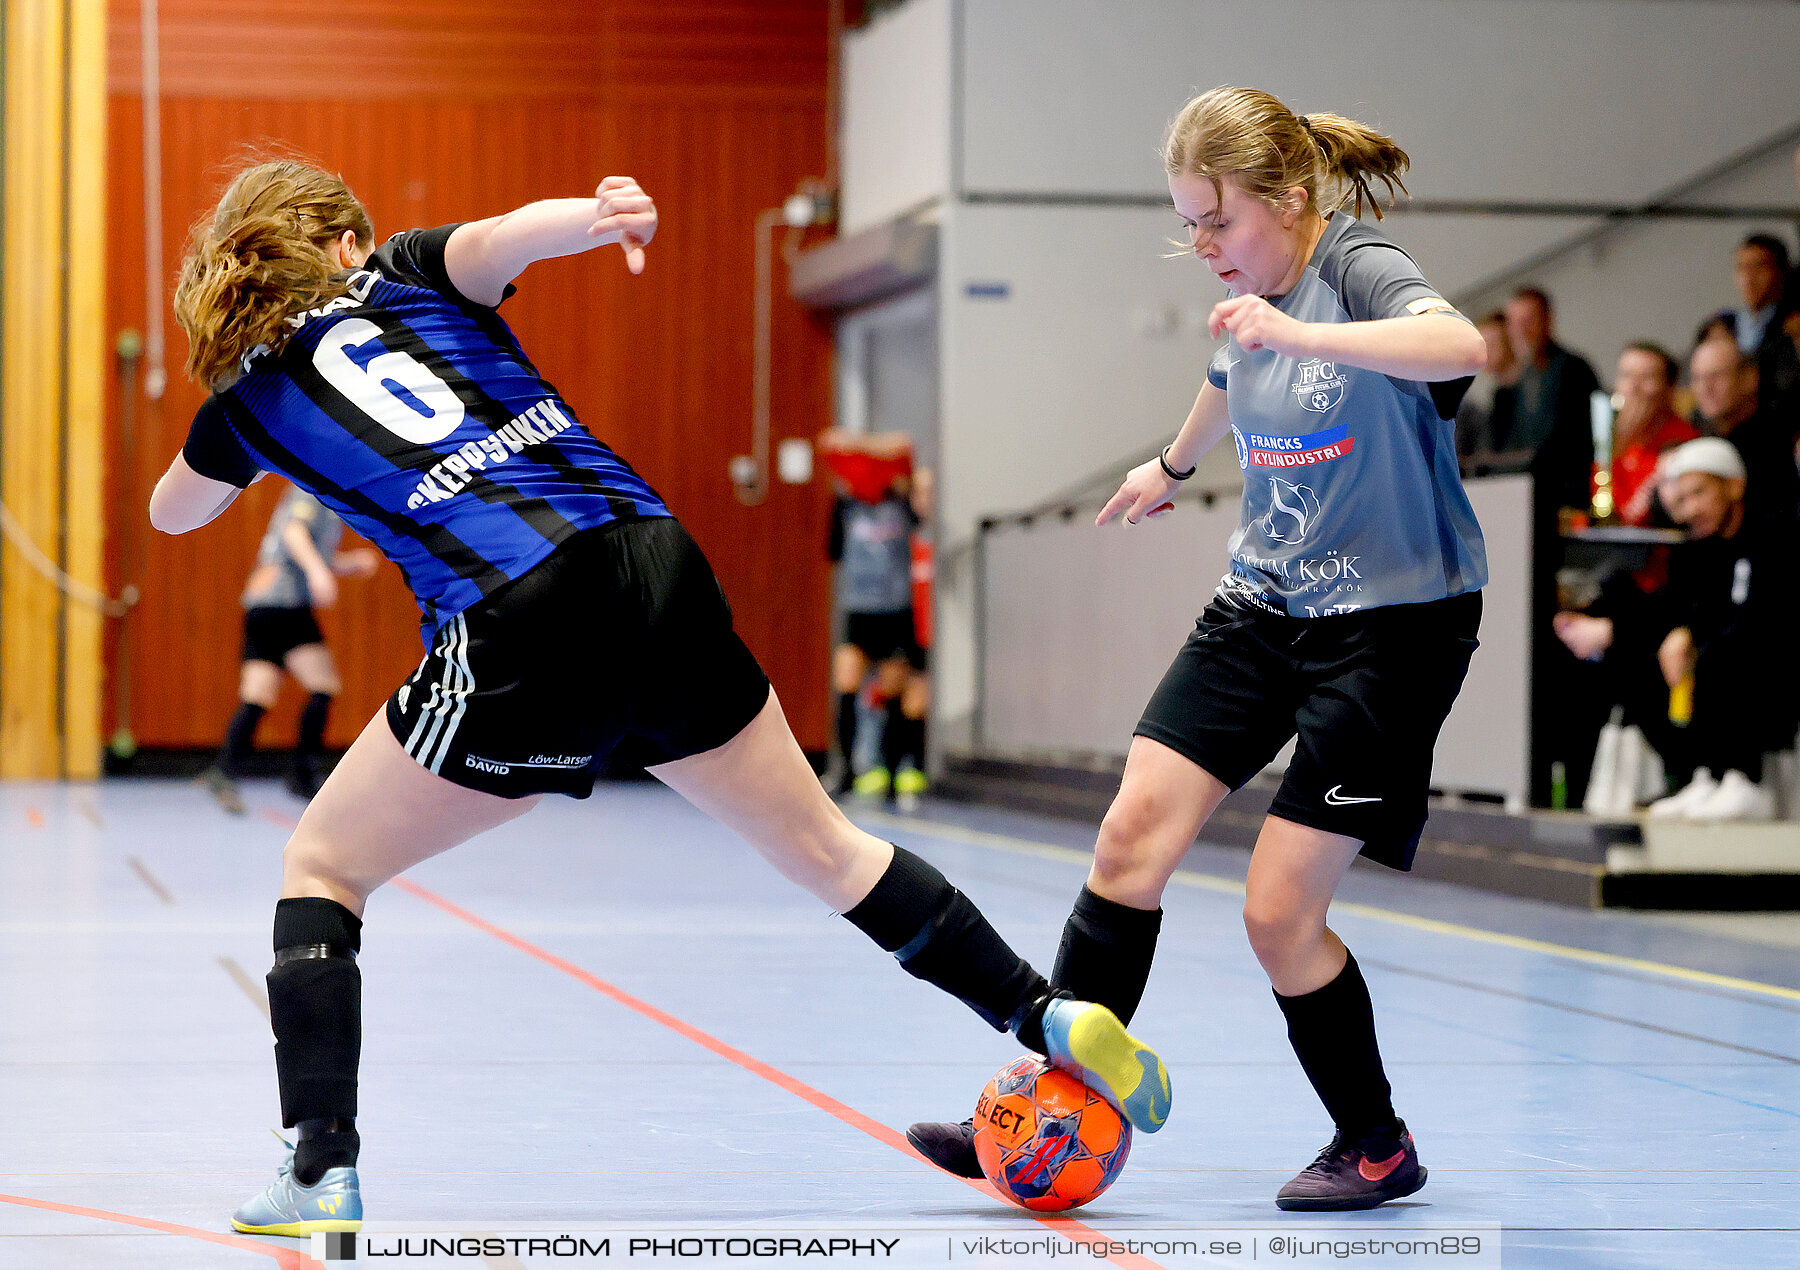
[1138,592,1481,869]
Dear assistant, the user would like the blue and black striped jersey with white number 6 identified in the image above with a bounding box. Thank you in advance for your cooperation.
[184,225,670,646]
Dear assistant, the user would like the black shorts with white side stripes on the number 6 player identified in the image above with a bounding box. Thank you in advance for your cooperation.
[387,516,769,799]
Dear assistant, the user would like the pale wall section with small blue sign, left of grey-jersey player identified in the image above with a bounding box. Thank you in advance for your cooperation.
[940,207,1235,538]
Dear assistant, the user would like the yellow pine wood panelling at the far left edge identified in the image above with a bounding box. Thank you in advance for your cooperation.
[0,0,106,779]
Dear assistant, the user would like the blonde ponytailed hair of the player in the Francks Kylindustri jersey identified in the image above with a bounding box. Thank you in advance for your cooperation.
[1163,88,1411,219]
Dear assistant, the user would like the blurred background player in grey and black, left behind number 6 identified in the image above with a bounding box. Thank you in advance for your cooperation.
[200,486,382,815]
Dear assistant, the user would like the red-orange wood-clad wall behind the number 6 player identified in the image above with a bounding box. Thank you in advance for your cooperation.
[108,0,830,750]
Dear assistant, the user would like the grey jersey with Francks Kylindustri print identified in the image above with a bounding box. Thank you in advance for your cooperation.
[1208,212,1487,617]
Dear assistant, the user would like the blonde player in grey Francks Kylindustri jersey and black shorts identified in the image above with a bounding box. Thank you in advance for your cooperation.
[909,88,1487,1209]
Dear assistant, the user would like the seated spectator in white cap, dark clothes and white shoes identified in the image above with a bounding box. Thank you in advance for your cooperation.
[1651,437,1800,820]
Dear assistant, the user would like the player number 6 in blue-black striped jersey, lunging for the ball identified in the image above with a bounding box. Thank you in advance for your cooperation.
[149,152,1161,1236]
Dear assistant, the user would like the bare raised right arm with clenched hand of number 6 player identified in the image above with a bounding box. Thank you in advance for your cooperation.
[445,176,657,304]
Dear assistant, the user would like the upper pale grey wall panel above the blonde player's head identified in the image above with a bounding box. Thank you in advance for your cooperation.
[961,0,1800,201]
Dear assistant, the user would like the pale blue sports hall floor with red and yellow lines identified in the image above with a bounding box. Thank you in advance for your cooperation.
[0,769,1800,1270]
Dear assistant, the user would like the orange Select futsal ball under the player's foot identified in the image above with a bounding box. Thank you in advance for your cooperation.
[976,1054,1130,1212]
